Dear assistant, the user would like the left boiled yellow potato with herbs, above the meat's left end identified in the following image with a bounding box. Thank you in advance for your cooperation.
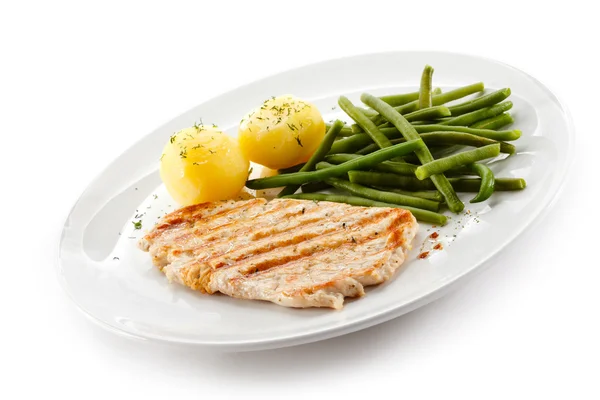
[160,125,249,206]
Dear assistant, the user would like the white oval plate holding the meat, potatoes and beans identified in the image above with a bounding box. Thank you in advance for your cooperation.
[58,52,574,351]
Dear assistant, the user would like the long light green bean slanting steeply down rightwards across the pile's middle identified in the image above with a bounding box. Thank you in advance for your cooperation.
[361,93,465,213]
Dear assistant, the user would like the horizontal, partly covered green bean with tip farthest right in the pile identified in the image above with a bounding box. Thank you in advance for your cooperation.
[348,171,527,193]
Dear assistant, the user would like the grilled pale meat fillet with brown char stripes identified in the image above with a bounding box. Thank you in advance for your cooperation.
[139,199,417,309]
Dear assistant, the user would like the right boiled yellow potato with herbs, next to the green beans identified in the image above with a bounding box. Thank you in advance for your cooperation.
[239,95,325,169]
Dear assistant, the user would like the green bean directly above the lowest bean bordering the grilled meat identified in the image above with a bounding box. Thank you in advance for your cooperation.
[325,178,440,211]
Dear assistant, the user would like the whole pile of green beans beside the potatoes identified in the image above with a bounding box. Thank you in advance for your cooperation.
[246,65,526,225]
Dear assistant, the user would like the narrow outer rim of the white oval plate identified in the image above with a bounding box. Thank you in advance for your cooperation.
[54,50,577,351]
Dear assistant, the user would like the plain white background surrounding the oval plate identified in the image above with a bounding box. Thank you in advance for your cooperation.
[0,0,600,399]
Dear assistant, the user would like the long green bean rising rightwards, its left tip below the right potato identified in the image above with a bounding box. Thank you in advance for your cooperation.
[246,138,425,189]
